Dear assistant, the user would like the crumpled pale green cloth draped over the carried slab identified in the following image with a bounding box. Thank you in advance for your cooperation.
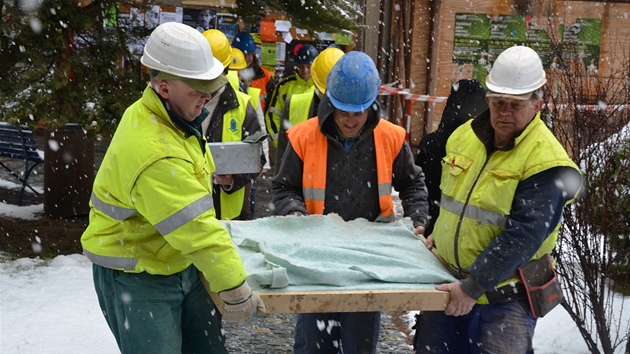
[224,214,455,291]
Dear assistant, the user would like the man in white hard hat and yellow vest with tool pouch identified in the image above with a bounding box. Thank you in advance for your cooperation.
[414,46,582,353]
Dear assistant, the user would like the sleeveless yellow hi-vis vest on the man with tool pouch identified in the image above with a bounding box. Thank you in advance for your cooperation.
[433,115,577,303]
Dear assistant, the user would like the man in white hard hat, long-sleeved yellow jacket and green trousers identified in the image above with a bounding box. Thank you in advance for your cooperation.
[81,22,264,354]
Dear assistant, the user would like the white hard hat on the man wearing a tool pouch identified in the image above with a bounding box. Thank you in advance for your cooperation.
[486,46,547,98]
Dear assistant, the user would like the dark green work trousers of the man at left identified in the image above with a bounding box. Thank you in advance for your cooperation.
[93,264,227,354]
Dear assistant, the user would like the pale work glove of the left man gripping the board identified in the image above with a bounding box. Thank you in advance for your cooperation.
[219,282,266,324]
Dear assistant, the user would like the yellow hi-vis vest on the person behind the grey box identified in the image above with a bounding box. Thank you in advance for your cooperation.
[221,90,250,220]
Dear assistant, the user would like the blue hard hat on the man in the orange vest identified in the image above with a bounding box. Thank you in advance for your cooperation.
[326,52,381,112]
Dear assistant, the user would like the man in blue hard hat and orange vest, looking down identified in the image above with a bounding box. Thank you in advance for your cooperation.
[272,52,428,353]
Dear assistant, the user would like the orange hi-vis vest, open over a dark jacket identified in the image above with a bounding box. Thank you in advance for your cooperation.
[288,119,405,221]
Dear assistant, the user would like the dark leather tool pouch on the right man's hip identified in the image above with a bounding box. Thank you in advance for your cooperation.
[518,254,564,318]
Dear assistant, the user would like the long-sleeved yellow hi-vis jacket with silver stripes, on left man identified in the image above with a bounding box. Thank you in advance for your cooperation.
[81,87,246,291]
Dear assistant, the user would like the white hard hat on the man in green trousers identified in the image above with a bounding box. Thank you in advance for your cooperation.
[140,22,223,80]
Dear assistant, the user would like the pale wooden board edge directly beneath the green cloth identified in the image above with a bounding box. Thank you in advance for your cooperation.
[258,290,450,313]
